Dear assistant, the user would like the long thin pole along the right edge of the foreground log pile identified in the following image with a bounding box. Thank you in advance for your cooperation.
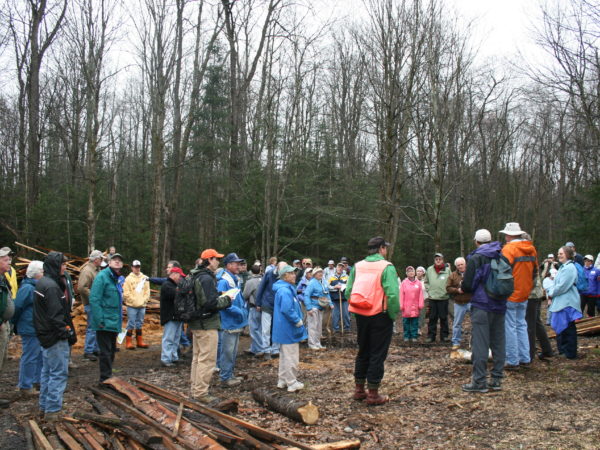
[131,378,312,450]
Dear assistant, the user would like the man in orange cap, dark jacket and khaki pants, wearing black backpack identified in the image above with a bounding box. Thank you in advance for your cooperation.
[188,248,231,403]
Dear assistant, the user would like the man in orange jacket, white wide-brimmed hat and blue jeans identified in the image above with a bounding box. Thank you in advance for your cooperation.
[500,222,538,369]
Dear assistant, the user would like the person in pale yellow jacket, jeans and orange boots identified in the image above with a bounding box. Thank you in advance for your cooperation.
[123,259,150,350]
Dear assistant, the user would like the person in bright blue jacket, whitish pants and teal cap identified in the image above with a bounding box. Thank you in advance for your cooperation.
[273,265,306,392]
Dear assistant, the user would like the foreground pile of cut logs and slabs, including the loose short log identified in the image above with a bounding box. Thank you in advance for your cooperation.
[25,378,360,450]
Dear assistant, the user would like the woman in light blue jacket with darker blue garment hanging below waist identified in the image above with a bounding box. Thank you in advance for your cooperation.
[547,247,583,359]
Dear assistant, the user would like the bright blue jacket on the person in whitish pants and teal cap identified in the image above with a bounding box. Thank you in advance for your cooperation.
[271,280,308,344]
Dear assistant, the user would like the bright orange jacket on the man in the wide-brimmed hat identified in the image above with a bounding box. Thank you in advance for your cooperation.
[502,239,538,303]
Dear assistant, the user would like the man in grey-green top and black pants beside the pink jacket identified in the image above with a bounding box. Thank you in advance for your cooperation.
[425,253,451,342]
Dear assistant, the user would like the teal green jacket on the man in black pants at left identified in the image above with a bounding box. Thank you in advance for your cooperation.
[90,267,123,333]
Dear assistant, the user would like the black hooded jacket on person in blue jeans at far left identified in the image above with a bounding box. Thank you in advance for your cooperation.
[33,252,77,348]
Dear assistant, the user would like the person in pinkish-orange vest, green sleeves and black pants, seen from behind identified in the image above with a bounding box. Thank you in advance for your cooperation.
[346,237,400,405]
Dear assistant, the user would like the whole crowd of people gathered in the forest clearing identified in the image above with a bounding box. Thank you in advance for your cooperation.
[0,223,600,421]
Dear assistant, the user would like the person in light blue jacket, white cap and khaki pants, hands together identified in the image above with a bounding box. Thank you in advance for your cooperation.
[304,267,333,350]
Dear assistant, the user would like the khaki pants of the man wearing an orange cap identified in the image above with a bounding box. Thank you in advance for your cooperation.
[191,330,219,397]
